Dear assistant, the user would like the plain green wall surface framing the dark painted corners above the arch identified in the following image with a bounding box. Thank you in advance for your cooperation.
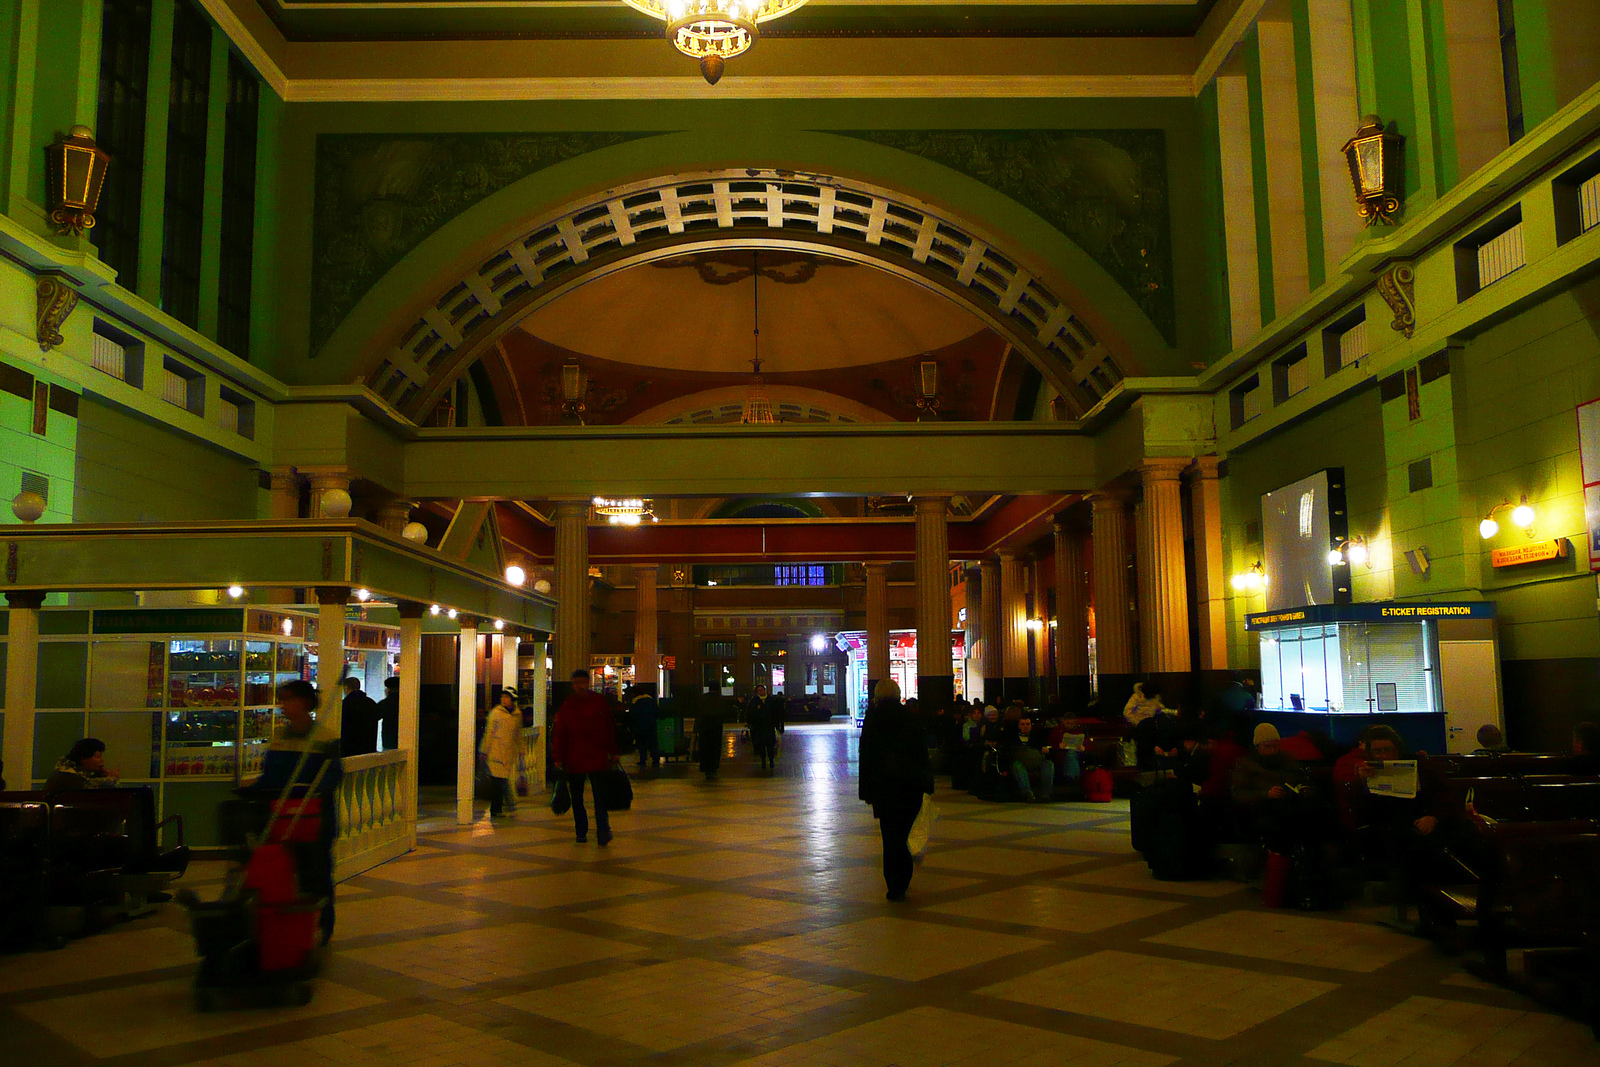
[272,99,1221,382]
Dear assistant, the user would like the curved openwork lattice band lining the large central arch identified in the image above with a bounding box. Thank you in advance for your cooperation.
[366,168,1123,418]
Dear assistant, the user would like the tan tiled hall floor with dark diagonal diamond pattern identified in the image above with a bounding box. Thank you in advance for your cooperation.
[0,726,1600,1067]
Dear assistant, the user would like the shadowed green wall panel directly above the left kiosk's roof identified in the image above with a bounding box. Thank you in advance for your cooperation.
[74,397,266,523]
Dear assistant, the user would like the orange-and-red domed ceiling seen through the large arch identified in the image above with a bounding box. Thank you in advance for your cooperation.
[474,250,1038,426]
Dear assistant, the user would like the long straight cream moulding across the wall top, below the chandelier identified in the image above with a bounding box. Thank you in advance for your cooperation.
[274,74,1194,104]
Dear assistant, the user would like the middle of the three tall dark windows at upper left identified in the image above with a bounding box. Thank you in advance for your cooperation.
[162,0,211,328]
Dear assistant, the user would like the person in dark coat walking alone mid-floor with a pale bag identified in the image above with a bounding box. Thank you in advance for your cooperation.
[859,678,933,901]
